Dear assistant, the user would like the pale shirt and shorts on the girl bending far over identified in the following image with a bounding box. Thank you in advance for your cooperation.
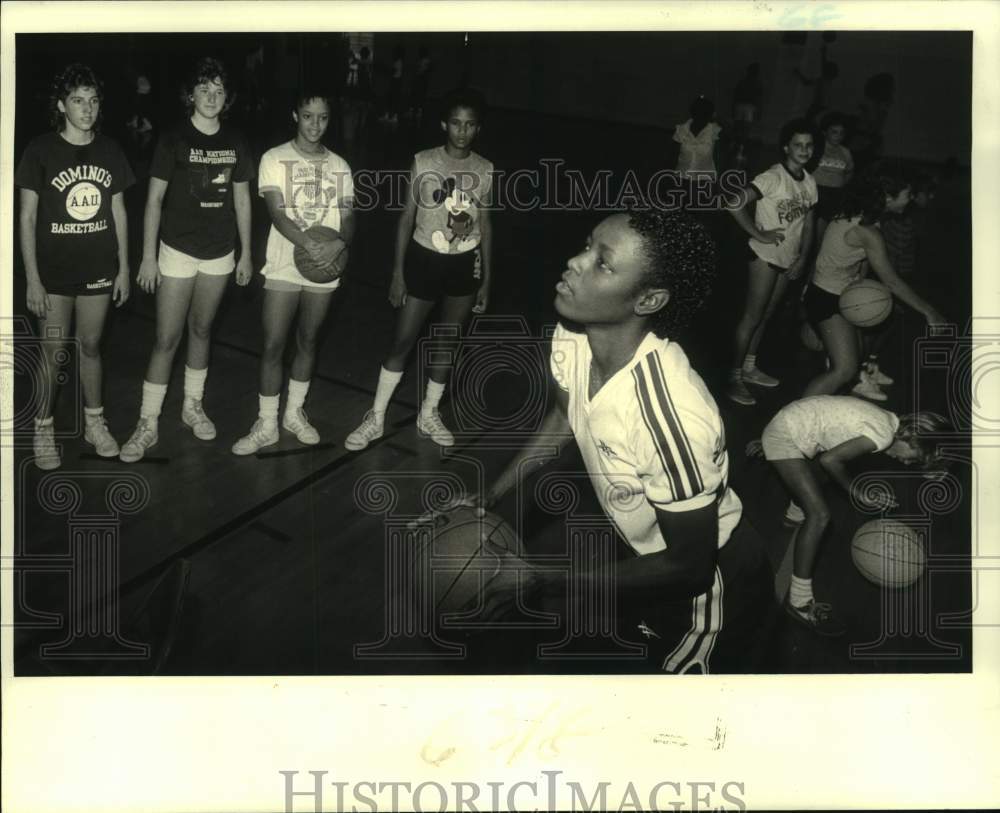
[771,395,899,459]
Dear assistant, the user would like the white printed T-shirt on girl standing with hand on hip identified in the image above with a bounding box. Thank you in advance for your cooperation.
[749,164,819,268]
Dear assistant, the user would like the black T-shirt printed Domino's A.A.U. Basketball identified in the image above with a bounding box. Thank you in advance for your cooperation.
[14,133,135,285]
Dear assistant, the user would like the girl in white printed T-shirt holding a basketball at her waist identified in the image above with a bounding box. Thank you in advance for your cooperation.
[233,90,354,455]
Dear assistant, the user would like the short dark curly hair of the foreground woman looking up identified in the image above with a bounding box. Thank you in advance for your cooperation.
[628,208,716,338]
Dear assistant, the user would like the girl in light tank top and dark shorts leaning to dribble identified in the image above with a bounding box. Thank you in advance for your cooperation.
[803,163,945,396]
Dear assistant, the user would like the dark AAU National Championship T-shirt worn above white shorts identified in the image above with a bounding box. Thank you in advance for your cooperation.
[149,120,254,260]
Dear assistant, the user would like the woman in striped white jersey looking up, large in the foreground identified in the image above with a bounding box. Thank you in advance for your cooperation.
[460,210,770,674]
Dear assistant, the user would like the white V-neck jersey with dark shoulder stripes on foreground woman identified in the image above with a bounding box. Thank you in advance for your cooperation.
[550,325,743,555]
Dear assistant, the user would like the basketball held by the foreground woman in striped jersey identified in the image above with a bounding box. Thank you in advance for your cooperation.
[413,506,522,616]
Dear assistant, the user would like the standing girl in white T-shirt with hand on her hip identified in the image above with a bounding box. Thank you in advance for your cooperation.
[726,119,817,406]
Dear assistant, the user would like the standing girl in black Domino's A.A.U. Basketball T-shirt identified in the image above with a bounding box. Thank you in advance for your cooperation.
[14,63,135,469]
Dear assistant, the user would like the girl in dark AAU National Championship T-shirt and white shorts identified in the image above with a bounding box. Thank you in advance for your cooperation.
[121,57,254,463]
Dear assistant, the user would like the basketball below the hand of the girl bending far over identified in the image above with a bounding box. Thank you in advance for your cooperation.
[851,519,927,587]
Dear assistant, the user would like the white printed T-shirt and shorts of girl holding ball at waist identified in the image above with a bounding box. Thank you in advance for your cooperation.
[258,141,354,289]
